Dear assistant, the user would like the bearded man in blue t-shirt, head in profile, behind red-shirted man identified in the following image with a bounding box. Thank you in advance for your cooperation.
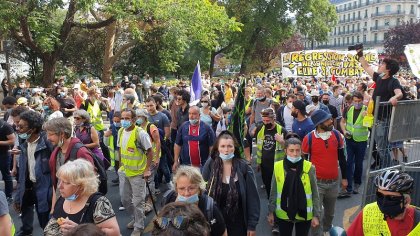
[291,100,315,140]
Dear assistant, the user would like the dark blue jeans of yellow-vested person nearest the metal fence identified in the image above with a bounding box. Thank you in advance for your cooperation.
[346,139,367,192]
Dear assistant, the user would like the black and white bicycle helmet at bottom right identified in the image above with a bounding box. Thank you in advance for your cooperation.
[375,170,414,193]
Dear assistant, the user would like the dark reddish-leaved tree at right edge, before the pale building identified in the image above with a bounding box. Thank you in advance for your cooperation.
[384,22,420,59]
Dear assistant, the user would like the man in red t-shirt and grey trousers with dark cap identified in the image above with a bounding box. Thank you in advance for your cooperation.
[302,109,347,236]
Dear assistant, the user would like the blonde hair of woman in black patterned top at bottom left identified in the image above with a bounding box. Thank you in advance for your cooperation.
[57,158,99,196]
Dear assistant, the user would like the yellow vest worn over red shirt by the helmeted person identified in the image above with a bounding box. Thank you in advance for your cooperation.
[362,202,420,236]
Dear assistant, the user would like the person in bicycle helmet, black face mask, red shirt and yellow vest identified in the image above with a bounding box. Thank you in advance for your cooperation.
[347,170,420,236]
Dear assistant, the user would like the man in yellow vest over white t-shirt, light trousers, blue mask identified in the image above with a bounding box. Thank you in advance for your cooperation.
[117,109,153,236]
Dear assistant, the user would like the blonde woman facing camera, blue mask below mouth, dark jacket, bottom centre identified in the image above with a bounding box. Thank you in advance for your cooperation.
[162,166,227,236]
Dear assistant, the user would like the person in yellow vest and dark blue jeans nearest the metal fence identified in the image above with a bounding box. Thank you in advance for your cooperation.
[339,92,369,197]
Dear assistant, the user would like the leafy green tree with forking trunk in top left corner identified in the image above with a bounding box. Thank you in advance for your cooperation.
[0,0,115,87]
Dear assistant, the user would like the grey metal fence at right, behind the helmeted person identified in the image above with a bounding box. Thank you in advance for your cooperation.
[362,98,420,207]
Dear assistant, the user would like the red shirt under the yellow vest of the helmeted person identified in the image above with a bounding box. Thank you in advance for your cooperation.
[347,207,414,236]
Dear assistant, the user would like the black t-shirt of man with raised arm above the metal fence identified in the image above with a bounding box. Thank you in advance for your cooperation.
[372,72,402,120]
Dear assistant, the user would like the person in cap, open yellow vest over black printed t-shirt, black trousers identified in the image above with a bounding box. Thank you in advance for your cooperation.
[255,108,286,198]
